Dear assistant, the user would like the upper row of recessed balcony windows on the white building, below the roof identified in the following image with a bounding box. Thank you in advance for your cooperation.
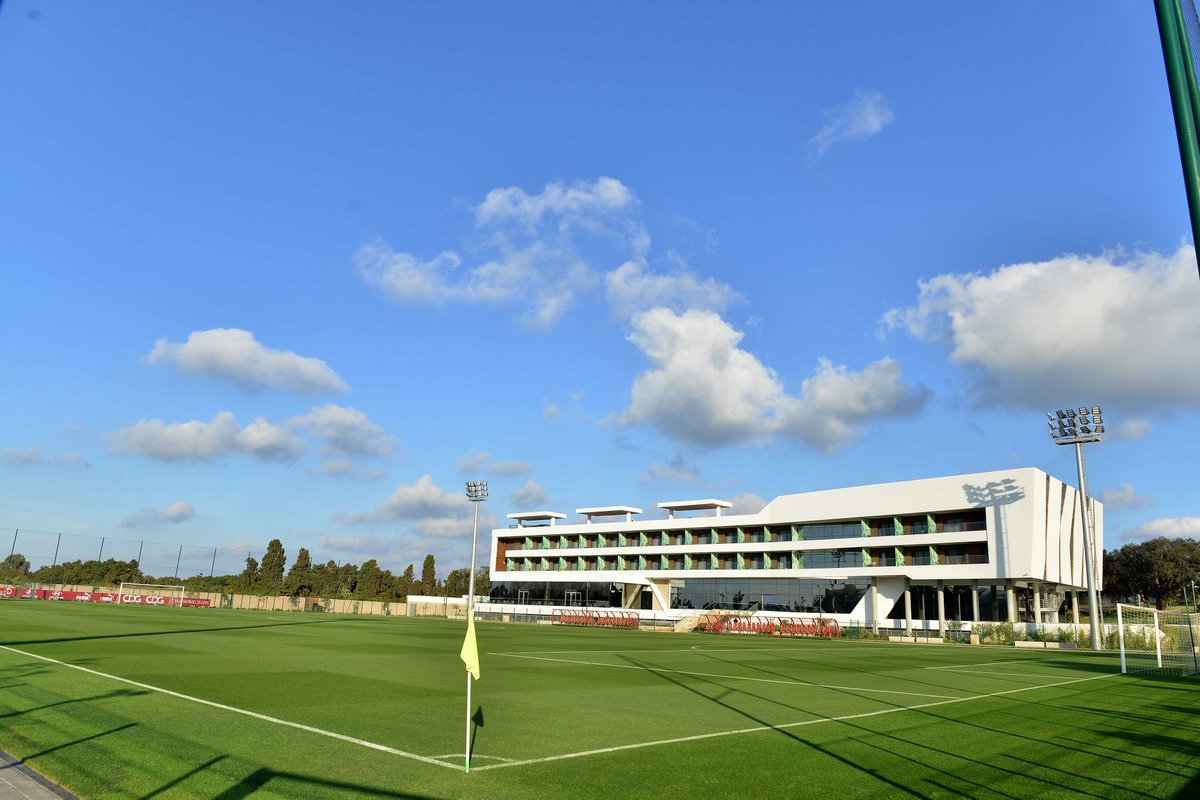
[500,513,986,551]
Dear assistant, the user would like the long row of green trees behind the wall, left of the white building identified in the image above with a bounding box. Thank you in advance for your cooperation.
[0,539,491,601]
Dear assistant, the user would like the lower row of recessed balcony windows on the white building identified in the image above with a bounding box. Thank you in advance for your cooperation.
[504,545,988,572]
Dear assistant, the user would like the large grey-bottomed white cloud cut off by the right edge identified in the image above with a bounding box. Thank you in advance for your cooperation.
[883,246,1200,410]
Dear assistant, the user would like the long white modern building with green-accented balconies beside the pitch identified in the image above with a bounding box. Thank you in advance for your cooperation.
[491,468,1104,630]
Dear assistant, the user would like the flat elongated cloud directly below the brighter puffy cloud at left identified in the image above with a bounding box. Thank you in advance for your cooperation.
[108,411,305,461]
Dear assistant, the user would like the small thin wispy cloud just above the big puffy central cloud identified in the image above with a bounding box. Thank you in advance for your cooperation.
[605,261,742,318]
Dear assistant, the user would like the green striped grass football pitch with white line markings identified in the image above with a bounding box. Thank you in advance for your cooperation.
[0,601,1200,800]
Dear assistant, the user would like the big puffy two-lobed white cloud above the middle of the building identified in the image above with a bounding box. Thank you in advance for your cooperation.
[620,308,929,452]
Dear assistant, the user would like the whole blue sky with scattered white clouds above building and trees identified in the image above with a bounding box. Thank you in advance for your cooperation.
[0,0,1200,573]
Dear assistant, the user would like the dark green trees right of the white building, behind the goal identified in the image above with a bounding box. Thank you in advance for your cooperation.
[1104,536,1200,609]
